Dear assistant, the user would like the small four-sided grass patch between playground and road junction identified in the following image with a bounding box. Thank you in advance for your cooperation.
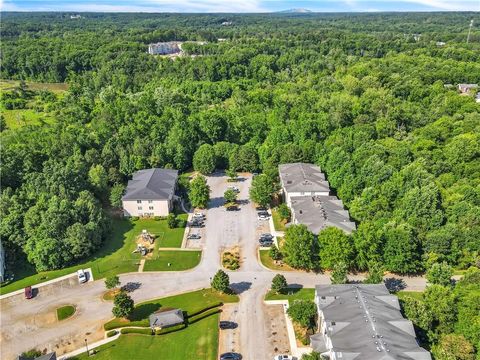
[143,250,202,271]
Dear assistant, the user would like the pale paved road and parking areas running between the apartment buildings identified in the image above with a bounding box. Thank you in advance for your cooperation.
[0,175,434,360]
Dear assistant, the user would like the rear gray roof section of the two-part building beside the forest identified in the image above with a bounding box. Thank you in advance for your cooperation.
[278,163,330,193]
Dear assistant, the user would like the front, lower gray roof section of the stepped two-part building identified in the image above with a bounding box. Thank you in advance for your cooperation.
[290,196,356,234]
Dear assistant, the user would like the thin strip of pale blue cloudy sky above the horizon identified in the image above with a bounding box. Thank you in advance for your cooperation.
[0,0,480,13]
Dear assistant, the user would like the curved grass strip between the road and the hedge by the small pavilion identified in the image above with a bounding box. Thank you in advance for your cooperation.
[104,289,238,329]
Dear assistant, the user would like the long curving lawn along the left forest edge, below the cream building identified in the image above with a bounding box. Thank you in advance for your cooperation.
[0,219,185,294]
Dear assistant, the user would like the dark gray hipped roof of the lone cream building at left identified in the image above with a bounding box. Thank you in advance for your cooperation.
[122,168,178,200]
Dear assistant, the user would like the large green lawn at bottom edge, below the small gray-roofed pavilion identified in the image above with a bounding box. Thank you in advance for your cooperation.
[71,314,219,360]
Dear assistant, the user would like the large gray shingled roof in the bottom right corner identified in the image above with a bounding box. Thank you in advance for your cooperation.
[311,284,431,360]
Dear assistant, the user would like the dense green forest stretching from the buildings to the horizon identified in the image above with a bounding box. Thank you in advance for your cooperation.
[0,13,480,359]
